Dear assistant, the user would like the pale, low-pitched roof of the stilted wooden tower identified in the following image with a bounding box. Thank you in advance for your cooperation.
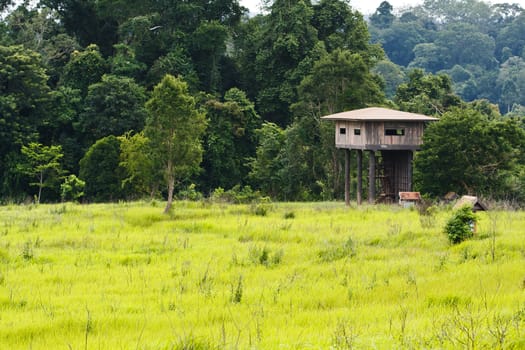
[321,107,438,122]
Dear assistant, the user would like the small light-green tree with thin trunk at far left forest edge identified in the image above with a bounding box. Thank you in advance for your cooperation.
[19,142,63,203]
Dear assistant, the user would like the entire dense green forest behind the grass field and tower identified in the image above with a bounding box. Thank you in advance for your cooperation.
[0,0,525,203]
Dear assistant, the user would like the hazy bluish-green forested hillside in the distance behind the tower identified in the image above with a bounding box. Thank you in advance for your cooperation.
[370,0,525,113]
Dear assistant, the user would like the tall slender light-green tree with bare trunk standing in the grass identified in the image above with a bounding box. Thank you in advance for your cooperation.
[144,75,206,213]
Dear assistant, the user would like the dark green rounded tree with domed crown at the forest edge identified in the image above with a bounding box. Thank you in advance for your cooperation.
[79,135,123,202]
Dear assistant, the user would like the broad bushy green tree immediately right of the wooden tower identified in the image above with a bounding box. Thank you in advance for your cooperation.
[414,106,525,198]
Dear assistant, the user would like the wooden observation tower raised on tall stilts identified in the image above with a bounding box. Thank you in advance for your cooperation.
[322,107,438,204]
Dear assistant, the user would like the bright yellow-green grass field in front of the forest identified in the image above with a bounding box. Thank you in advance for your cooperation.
[0,202,525,349]
